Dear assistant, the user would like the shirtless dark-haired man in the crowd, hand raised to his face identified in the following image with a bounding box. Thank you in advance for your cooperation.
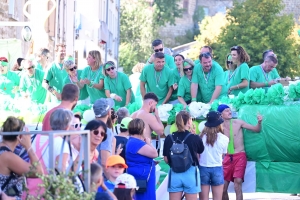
[131,92,164,138]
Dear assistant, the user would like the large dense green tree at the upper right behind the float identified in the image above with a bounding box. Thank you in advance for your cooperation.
[214,0,300,77]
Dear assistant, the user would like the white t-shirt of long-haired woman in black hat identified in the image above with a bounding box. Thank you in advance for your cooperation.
[199,133,229,167]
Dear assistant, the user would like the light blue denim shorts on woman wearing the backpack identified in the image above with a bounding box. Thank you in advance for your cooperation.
[168,166,201,194]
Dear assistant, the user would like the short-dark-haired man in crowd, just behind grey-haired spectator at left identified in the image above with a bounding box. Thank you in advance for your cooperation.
[42,84,79,131]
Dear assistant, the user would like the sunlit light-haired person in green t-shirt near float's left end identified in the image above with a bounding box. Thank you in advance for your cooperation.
[20,60,47,104]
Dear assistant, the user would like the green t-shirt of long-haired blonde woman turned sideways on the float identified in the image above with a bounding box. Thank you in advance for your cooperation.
[80,66,106,104]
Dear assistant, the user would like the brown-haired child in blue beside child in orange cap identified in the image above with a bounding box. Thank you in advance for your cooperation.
[91,163,118,200]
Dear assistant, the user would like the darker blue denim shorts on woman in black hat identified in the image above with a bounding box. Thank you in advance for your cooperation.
[200,166,224,186]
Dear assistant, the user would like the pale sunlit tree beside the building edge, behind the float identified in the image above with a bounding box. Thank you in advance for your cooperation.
[120,0,182,73]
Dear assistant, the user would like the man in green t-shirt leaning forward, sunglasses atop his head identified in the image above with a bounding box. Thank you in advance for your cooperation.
[191,52,226,103]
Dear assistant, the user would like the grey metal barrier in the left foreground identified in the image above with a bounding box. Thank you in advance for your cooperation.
[0,130,91,192]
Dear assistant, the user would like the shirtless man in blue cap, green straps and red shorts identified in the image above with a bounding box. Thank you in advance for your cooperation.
[218,104,263,200]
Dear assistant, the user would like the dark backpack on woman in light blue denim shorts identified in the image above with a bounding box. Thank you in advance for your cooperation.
[170,133,194,173]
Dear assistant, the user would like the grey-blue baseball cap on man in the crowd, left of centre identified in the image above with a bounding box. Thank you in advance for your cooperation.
[93,98,115,118]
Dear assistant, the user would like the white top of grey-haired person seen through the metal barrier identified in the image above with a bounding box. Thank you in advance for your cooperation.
[32,135,70,169]
